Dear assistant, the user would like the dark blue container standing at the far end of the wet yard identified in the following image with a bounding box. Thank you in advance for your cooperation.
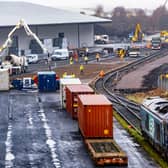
[37,71,57,92]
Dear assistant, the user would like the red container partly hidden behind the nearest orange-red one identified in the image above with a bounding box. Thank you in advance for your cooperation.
[66,84,94,119]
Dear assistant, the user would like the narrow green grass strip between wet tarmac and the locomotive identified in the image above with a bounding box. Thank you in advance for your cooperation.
[114,112,168,168]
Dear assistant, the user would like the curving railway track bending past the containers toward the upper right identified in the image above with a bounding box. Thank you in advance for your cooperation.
[94,49,168,133]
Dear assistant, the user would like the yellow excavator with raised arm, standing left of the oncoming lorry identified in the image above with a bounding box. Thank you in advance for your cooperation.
[131,23,144,42]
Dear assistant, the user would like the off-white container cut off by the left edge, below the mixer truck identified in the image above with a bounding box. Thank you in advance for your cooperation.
[0,69,10,91]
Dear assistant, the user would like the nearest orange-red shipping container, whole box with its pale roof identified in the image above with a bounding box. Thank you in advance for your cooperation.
[78,95,113,138]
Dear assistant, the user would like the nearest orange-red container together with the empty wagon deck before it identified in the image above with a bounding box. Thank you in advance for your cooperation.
[78,95,128,166]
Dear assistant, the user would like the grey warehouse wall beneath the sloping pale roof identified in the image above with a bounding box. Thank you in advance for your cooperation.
[0,24,94,54]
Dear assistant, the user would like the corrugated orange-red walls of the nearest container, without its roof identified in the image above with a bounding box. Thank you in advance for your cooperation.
[78,97,113,138]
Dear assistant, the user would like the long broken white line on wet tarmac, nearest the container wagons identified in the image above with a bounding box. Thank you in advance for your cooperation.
[38,100,61,168]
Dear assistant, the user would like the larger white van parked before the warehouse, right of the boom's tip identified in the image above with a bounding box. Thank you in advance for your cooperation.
[51,49,69,60]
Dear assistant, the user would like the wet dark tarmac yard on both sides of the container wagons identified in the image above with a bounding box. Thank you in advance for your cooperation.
[0,90,158,168]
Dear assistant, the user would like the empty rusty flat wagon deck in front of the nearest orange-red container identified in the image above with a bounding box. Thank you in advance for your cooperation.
[85,139,128,166]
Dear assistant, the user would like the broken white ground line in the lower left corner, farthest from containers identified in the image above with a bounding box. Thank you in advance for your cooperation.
[5,122,15,168]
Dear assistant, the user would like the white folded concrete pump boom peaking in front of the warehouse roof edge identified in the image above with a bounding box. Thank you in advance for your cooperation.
[0,19,48,53]
